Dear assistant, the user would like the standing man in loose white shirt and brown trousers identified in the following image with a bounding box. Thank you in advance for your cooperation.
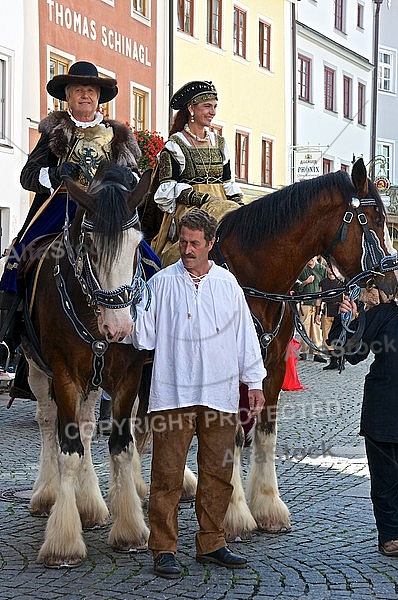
[133,208,266,578]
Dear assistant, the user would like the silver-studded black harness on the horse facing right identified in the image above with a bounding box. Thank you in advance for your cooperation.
[213,198,398,361]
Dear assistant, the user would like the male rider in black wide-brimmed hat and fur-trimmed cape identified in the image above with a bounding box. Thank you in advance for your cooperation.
[0,61,151,398]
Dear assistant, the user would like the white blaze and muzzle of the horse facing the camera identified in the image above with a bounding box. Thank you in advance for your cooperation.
[97,228,142,342]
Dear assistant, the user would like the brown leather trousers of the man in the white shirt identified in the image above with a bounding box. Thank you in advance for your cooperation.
[148,406,237,557]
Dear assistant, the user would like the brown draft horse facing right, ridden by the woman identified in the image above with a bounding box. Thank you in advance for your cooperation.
[213,159,397,539]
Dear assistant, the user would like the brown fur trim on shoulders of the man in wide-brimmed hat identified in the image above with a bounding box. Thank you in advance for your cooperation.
[39,110,141,170]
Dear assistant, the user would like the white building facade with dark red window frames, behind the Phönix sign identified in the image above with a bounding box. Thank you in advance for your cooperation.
[291,0,374,180]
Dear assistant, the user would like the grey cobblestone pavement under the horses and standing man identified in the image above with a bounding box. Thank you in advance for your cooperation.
[0,362,398,600]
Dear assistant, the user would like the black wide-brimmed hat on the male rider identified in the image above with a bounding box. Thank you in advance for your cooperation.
[47,60,119,104]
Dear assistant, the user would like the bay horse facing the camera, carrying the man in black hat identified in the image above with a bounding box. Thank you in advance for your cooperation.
[22,163,154,568]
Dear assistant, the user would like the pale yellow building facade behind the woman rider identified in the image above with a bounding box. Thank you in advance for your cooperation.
[172,0,290,198]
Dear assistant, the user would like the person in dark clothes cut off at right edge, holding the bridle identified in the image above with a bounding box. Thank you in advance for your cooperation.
[329,297,398,556]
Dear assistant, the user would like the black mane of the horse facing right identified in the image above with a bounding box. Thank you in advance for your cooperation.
[217,171,384,251]
